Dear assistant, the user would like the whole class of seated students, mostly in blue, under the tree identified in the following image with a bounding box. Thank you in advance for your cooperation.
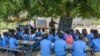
[0,27,100,56]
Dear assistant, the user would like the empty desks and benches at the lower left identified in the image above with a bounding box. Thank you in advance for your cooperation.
[0,37,42,56]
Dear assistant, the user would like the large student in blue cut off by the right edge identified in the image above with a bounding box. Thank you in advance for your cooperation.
[91,30,100,56]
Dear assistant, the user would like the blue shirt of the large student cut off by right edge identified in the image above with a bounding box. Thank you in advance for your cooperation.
[91,38,100,52]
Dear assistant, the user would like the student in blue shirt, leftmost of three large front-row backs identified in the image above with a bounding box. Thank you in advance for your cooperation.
[40,34,52,56]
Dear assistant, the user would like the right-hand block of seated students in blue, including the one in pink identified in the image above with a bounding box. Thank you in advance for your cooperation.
[40,29,100,56]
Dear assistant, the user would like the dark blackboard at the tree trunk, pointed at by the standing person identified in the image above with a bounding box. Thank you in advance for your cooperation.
[59,16,73,31]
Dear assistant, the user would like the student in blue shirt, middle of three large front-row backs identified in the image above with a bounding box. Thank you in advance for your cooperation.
[54,32,68,56]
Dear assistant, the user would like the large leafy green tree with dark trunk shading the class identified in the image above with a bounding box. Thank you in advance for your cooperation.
[0,0,100,30]
